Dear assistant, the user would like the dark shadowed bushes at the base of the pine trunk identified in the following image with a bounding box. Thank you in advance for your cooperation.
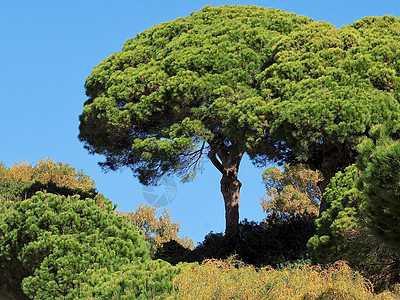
[156,214,315,267]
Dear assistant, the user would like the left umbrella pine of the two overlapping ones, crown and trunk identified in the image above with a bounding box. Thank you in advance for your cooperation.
[79,6,311,238]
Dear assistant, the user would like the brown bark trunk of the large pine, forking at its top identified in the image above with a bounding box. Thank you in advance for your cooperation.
[208,146,243,240]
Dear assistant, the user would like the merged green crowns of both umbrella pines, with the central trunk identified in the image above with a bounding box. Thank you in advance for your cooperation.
[79,6,400,237]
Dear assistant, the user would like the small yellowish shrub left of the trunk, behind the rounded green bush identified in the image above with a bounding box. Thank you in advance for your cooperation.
[119,205,194,255]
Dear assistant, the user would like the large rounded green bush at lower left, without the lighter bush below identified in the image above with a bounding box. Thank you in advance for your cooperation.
[0,192,150,299]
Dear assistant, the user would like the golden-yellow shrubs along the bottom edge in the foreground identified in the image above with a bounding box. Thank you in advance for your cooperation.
[175,258,398,300]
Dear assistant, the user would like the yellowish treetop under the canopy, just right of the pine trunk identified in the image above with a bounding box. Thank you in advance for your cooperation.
[261,165,322,216]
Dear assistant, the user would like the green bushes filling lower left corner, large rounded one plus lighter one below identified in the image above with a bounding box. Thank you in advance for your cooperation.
[0,192,178,299]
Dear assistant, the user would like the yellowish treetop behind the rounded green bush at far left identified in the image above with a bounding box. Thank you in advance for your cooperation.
[0,157,94,191]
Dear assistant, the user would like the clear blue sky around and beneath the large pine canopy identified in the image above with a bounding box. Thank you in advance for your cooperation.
[0,0,400,242]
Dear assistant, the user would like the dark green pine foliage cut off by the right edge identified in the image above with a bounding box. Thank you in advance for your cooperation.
[357,126,400,256]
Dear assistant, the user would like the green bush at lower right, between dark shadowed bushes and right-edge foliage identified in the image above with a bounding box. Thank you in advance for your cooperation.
[308,165,399,290]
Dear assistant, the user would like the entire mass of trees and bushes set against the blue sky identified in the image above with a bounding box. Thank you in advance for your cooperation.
[0,6,400,299]
